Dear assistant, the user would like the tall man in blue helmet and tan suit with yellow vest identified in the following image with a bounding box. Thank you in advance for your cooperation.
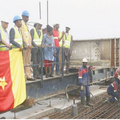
[20,11,34,80]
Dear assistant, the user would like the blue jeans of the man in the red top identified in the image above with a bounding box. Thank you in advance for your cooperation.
[51,48,60,74]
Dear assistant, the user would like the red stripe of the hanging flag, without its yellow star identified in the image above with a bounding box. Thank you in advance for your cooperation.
[0,51,14,112]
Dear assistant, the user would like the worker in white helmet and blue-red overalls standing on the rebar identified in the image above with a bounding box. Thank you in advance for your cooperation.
[78,58,92,107]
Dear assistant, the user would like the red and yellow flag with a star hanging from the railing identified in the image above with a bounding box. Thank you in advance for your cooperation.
[0,49,26,112]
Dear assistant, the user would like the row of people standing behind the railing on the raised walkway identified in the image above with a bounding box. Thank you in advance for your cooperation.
[0,10,73,80]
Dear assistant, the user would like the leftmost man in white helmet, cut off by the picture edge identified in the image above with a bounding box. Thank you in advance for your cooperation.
[0,18,11,51]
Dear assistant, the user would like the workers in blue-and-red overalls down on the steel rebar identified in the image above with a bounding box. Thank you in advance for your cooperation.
[78,58,120,108]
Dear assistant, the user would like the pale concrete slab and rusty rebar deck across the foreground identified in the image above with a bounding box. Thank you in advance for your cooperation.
[0,85,120,119]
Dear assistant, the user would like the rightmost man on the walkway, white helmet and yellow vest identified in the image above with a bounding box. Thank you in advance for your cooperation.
[63,26,73,74]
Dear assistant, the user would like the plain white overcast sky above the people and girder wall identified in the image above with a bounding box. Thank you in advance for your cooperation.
[0,0,120,40]
